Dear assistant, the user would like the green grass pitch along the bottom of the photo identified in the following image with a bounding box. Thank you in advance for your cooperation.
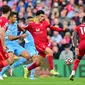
[0,77,85,85]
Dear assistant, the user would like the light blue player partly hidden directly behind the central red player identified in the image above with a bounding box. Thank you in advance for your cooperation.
[20,16,39,79]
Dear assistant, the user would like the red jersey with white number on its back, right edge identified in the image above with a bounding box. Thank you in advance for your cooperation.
[75,23,85,41]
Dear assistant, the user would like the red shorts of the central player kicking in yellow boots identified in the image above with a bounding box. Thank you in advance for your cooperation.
[36,42,51,57]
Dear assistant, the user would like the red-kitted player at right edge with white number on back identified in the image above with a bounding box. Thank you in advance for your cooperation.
[70,16,85,81]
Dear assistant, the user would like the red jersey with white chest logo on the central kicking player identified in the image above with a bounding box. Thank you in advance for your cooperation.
[26,21,49,44]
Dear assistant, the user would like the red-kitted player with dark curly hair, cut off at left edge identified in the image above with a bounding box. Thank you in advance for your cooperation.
[0,5,11,70]
